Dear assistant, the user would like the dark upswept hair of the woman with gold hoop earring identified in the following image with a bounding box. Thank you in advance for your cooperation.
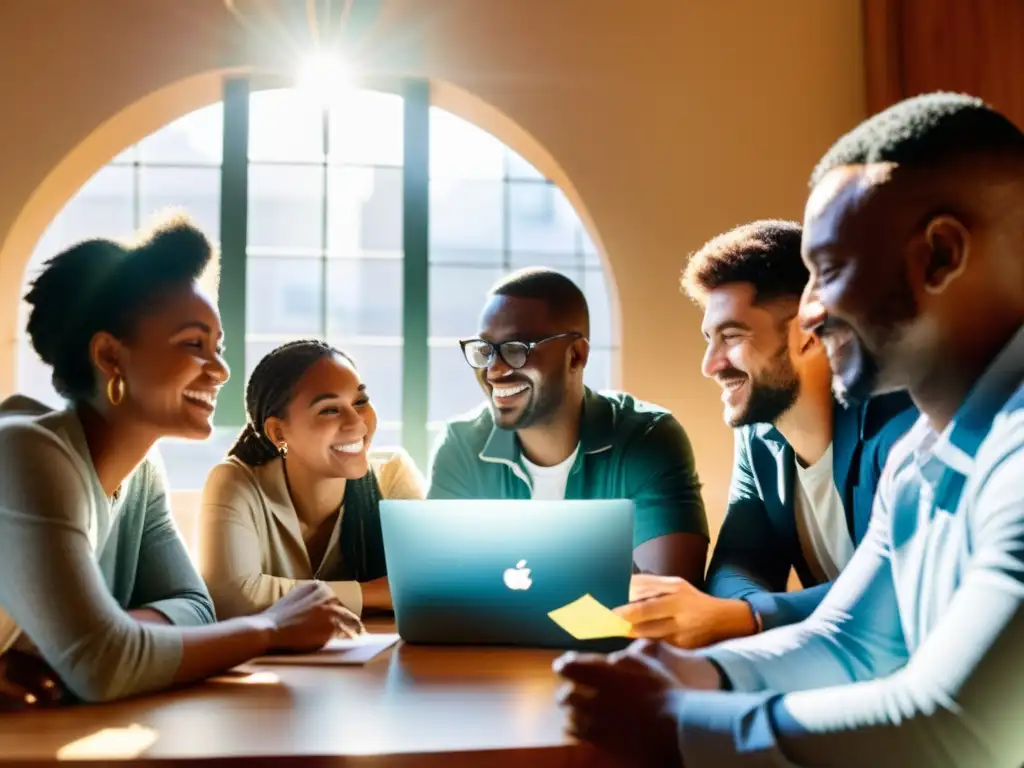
[25,215,217,400]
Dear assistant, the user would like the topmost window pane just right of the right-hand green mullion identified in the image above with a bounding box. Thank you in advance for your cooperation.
[430,106,505,180]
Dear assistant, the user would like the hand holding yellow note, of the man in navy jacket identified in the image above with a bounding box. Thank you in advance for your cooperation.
[614,573,757,648]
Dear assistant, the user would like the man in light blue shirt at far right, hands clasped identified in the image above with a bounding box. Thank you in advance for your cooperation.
[556,93,1024,768]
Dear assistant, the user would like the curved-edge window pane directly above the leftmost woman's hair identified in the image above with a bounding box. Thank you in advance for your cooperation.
[26,166,135,268]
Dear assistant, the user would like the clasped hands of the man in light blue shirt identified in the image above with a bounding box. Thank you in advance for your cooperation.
[554,651,682,766]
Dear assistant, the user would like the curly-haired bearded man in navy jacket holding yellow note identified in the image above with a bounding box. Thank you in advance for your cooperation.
[617,220,918,648]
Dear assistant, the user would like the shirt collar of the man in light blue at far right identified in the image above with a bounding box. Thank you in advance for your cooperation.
[908,326,1024,476]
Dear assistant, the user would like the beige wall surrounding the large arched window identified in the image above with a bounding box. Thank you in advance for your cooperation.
[0,0,864,540]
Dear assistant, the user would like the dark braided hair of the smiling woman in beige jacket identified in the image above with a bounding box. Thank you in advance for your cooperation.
[227,339,354,467]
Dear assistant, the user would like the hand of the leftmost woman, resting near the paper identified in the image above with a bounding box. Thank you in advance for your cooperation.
[263,582,364,652]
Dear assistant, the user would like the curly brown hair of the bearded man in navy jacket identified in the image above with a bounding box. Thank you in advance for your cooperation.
[682,219,810,307]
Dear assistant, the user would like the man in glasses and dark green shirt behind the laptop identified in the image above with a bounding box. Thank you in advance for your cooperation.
[428,268,708,584]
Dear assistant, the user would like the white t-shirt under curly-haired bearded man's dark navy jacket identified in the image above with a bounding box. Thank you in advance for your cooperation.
[796,443,853,582]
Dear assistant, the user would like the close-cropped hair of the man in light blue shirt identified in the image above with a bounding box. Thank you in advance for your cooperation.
[810,92,1024,188]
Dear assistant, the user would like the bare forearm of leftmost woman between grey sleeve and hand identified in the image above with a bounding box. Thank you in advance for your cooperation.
[174,616,273,685]
